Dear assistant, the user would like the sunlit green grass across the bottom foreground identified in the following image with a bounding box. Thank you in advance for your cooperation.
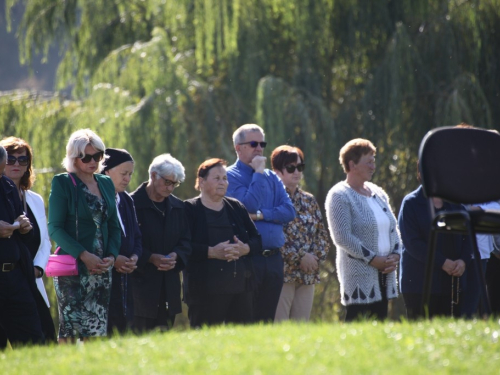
[0,320,500,375]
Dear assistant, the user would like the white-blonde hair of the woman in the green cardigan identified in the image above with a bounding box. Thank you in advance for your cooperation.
[62,129,106,172]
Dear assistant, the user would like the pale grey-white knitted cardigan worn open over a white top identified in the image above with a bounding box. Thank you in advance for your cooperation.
[325,181,401,306]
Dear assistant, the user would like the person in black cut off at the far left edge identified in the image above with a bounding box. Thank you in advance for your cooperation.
[0,146,44,350]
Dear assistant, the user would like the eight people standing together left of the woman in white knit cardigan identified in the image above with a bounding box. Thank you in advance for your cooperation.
[0,124,329,346]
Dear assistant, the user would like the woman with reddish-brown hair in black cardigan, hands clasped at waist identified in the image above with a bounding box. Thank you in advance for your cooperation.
[184,159,262,327]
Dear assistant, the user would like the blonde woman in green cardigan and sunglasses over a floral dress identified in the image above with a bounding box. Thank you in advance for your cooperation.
[48,129,121,343]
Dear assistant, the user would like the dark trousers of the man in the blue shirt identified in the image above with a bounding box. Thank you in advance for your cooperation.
[252,251,284,323]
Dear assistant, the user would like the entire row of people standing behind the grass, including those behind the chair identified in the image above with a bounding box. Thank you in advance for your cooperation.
[0,124,492,346]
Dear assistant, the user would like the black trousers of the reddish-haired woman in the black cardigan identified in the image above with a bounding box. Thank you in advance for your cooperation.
[188,292,253,328]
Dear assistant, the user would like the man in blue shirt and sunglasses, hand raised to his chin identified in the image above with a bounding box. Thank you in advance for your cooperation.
[226,124,295,322]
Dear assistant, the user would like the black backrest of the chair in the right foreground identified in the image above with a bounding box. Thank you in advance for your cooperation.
[419,127,500,204]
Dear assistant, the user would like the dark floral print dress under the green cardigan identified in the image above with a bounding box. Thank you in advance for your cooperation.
[54,185,111,338]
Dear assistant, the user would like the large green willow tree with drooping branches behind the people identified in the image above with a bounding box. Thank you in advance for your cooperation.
[0,0,500,322]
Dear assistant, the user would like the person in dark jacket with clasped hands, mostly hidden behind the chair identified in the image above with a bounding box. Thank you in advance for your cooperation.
[398,186,472,319]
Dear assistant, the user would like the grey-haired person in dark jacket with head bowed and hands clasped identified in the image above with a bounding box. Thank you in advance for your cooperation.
[131,154,191,332]
